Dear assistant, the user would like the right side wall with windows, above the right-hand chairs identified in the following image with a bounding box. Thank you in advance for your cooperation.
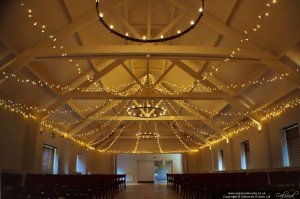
[188,97,300,173]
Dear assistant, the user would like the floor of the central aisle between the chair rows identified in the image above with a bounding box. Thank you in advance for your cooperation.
[114,183,182,199]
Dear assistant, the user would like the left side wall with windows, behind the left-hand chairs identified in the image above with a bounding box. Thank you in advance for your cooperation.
[0,110,114,174]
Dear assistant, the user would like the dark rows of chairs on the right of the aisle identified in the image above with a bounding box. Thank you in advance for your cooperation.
[167,170,300,199]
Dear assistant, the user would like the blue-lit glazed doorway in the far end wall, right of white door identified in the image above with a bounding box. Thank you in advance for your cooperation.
[154,160,172,182]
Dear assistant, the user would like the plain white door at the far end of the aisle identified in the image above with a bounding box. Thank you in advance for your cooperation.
[137,160,154,182]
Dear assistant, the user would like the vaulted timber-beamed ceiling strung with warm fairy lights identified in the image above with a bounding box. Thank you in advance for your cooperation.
[0,0,300,153]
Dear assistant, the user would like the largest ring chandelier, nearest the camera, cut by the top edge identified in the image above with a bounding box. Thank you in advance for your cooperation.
[96,0,204,43]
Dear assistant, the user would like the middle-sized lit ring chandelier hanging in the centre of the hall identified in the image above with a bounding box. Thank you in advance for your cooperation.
[127,100,167,118]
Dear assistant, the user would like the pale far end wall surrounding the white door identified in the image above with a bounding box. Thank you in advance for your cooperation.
[117,154,182,182]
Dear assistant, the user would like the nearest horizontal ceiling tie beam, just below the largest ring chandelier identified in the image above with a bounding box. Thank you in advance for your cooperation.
[29,44,277,62]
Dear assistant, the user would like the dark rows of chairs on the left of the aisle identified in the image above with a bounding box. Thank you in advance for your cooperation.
[1,173,126,199]
